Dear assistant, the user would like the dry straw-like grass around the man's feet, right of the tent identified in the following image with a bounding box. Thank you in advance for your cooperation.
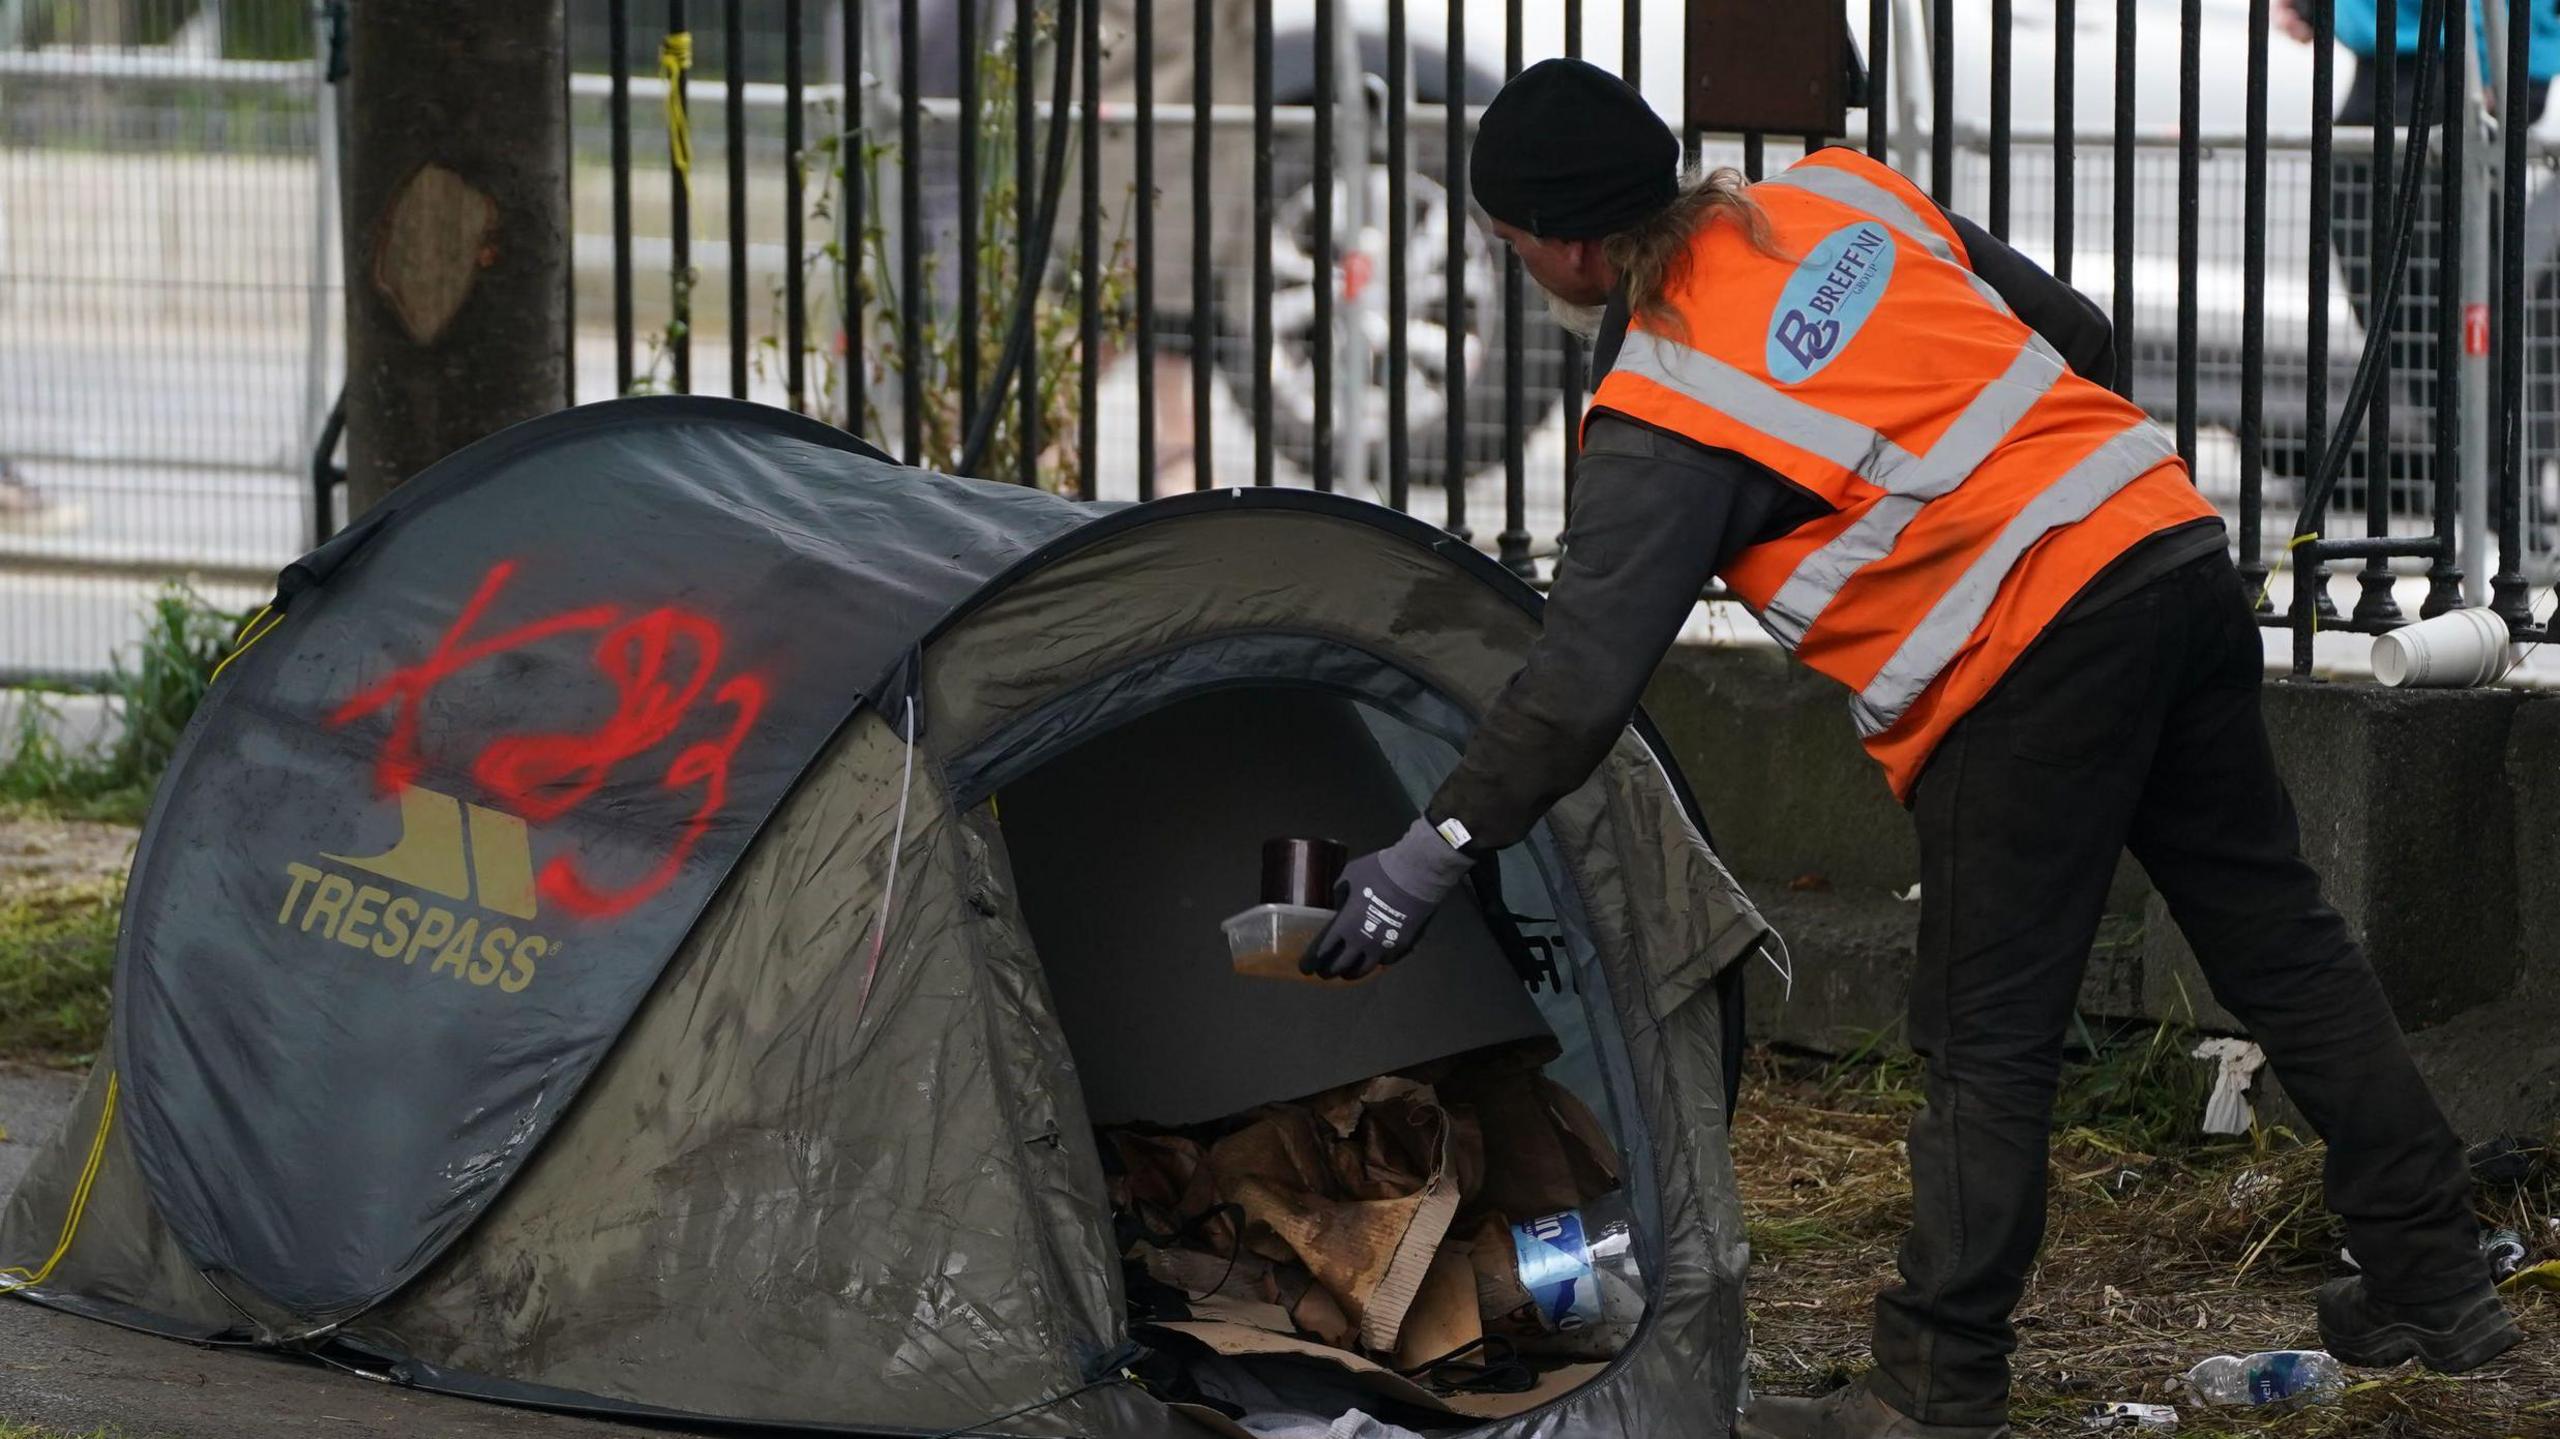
[1733,1024,2560,1439]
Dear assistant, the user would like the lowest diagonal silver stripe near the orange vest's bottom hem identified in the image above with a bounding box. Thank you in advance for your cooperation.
[1848,420,2176,735]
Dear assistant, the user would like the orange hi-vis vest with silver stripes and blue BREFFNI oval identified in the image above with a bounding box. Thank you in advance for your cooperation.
[1592,149,2214,799]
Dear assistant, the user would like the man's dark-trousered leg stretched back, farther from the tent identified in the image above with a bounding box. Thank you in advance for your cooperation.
[2130,555,2488,1303]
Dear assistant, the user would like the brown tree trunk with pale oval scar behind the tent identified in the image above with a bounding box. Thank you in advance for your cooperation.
[343,0,571,515]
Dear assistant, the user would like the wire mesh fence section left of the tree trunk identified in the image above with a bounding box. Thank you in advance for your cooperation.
[0,5,340,681]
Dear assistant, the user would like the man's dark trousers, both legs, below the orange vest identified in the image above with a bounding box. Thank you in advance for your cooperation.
[1874,556,2488,1424]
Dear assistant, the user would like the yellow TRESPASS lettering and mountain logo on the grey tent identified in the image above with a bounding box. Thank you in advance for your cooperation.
[276,784,561,993]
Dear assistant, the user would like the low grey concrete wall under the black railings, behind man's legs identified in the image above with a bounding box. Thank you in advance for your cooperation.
[1646,645,2560,1134]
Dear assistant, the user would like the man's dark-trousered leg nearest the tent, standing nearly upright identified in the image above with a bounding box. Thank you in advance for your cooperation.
[1869,589,2161,1426]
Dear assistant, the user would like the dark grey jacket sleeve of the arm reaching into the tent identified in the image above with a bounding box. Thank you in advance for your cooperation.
[1428,415,1823,850]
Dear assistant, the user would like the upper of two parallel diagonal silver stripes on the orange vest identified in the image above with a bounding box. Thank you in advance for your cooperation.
[1761,335,2063,637]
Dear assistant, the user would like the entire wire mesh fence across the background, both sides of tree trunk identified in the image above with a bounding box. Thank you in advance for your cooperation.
[15,0,2560,676]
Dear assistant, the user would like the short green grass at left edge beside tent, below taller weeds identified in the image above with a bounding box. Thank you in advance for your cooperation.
[0,878,125,1060]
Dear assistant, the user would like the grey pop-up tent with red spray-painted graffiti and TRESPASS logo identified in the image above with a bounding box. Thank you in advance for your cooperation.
[0,399,1764,1439]
